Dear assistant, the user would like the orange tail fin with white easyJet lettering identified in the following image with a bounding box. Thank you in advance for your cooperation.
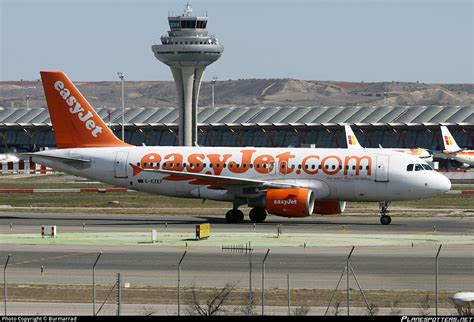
[41,71,130,149]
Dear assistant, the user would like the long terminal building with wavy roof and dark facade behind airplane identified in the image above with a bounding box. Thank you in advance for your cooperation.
[0,106,474,165]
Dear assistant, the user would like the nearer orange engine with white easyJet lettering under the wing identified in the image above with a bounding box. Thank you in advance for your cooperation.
[249,188,315,217]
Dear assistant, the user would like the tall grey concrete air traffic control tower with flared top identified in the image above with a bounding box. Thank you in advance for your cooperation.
[151,4,224,146]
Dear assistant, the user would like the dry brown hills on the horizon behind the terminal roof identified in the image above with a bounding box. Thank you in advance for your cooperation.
[0,79,474,108]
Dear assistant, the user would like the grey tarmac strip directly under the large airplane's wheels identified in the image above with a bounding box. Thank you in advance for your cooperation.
[0,210,474,235]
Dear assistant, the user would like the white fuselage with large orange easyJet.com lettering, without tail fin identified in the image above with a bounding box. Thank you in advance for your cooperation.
[33,146,450,201]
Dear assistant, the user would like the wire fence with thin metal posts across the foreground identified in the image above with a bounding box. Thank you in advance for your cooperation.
[0,243,472,315]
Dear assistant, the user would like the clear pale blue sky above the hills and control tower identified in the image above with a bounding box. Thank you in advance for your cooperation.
[0,0,474,83]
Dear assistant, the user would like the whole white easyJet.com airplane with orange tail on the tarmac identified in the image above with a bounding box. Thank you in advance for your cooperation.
[23,71,451,224]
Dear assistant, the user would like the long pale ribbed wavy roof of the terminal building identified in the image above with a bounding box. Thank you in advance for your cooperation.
[0,106,474,127]
